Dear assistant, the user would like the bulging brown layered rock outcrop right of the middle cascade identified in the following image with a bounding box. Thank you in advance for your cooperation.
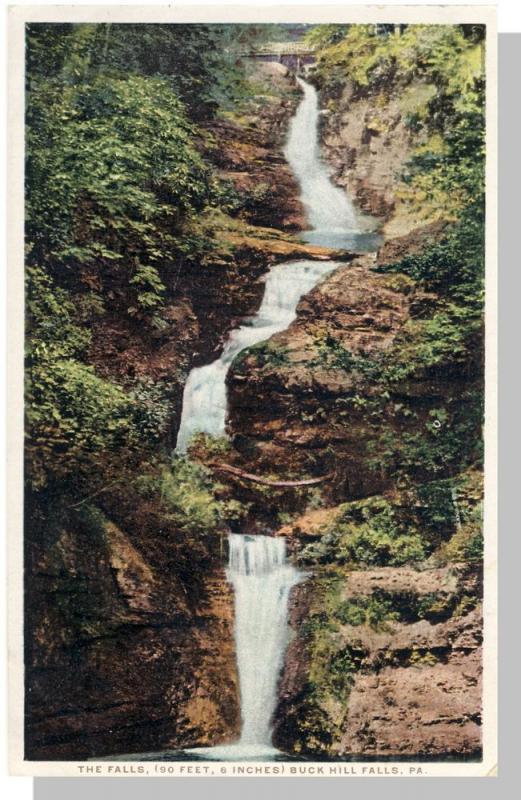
[228,245,449,498]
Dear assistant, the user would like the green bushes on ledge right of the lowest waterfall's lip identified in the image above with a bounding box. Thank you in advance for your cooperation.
[298,467,483,576]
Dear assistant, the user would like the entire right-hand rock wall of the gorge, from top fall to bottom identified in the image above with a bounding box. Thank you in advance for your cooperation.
[228,32,482,759]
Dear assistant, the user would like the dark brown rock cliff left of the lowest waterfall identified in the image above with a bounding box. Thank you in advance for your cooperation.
[26,494,240,760]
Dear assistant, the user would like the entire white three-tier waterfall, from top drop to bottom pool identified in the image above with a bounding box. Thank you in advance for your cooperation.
[176,79,375,760]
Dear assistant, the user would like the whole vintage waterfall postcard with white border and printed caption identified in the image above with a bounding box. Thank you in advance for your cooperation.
[9,0,497,777]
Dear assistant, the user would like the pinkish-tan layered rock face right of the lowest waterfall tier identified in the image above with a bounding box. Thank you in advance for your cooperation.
[275,552,482,759]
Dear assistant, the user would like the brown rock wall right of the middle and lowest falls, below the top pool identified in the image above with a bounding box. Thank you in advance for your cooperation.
[229,236,482,758]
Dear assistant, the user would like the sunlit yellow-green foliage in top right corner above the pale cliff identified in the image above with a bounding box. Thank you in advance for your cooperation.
[308,25,485,219]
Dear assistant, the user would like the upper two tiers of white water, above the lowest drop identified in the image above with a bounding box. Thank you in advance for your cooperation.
[176,78,371,453]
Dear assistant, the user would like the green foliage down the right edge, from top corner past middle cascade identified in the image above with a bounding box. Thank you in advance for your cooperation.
[302,25,485,496]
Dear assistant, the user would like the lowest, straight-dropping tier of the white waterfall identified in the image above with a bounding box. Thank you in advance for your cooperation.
[228,534,302,747]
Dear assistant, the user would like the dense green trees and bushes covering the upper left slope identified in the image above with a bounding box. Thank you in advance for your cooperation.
[26,24,280,494]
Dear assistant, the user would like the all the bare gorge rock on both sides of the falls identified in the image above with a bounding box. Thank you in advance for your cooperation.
[26,26,482,760]
